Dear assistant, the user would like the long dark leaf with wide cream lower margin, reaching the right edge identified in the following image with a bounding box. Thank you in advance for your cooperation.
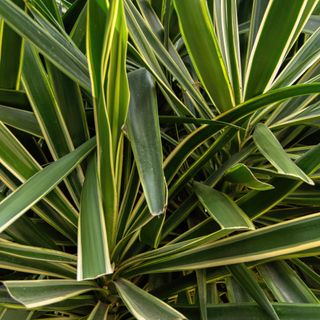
[122,212,320,276]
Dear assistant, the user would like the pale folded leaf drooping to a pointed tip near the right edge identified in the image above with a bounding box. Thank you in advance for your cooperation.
[253,123,314,185]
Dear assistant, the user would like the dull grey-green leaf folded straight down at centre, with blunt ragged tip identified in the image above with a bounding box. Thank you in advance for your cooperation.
[126,69,167,215]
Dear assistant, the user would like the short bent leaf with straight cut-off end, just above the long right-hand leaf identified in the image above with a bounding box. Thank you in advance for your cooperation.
[194,182,254,230]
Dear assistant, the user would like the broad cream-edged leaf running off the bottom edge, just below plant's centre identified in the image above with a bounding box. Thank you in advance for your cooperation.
[114,278,186,320]
